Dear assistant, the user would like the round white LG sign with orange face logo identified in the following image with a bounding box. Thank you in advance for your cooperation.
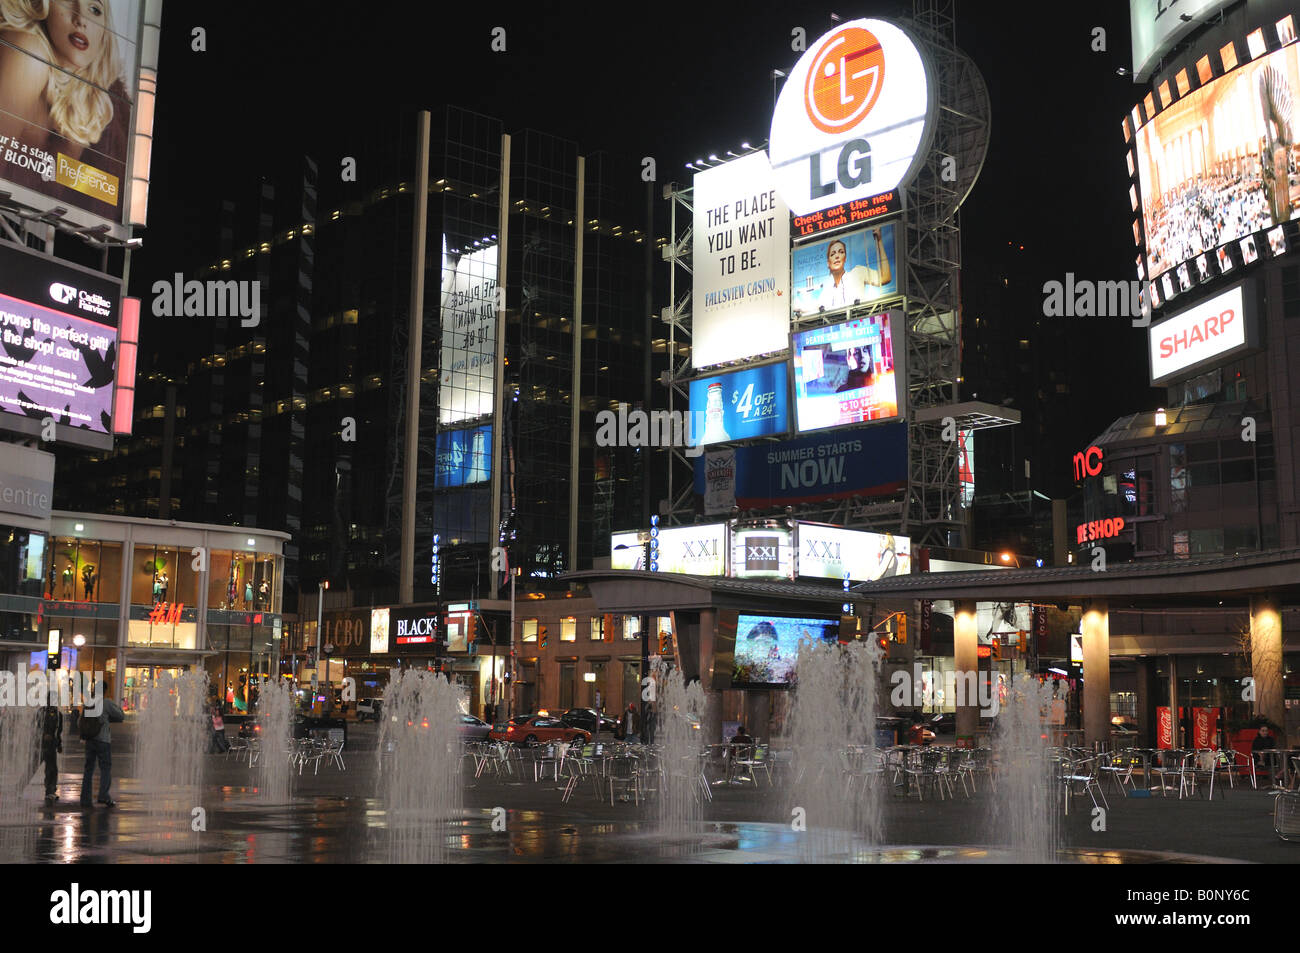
[770,20,932,216]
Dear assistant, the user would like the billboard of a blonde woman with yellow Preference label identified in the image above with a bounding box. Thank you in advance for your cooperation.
[0,0,142,224]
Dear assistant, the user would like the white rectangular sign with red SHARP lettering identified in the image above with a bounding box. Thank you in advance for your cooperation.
[1147,281,1257,385]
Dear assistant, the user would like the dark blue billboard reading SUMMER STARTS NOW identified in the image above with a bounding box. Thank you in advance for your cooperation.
[696,423,907,514]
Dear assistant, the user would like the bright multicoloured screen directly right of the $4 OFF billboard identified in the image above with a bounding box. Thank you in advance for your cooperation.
[790,311,902,433]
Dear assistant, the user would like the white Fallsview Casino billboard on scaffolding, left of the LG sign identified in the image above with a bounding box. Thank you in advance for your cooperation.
[690,152,790,368]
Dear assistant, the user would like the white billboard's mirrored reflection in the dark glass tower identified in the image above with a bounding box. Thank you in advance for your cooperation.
[438,235,497,424]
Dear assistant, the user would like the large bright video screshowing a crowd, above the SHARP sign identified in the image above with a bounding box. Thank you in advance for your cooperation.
[1136,44,1300,278]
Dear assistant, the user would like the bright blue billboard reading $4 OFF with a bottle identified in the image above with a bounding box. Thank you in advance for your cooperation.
[690,361,790,446]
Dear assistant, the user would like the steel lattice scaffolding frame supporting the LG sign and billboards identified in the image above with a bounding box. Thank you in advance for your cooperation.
[660,0,993,547]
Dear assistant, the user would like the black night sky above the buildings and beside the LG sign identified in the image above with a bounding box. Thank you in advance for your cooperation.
[133,0,1151,462]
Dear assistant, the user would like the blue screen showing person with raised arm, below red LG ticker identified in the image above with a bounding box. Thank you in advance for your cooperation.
[790,222,898,317]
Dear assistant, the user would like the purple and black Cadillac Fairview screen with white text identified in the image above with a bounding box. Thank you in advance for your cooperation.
[0,243,122,441]
